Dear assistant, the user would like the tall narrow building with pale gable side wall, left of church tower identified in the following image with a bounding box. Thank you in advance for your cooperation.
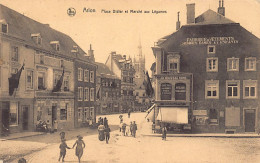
[105,52,135,112]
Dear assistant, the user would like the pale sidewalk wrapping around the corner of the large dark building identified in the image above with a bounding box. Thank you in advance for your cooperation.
[141,122,260,138]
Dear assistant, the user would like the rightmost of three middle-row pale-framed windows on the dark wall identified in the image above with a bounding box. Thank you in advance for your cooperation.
[243,80,257,98]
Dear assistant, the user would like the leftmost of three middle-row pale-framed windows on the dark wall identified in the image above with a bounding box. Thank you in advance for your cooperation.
[205,80,219,99]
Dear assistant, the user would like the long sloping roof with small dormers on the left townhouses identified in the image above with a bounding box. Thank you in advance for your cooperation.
[0,4,90,60]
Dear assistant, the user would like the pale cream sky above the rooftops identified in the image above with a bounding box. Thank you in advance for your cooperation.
[0,0,260,70]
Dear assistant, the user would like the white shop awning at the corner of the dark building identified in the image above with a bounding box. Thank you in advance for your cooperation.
[156,107,188,124]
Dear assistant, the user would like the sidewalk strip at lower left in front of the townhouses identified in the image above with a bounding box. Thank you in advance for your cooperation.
[0,132,46,141]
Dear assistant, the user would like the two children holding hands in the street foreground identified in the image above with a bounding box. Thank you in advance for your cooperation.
[59,132,85,162]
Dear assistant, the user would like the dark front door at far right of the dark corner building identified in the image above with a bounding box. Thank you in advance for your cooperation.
[245,109,255,132]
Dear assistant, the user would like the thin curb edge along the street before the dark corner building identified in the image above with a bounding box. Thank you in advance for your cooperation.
[142,134,260,138]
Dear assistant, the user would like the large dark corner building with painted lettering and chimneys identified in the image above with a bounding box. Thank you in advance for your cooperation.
[153,2,260,132]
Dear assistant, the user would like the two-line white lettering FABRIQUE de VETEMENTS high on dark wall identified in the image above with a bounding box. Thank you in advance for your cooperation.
[181,37,238,45]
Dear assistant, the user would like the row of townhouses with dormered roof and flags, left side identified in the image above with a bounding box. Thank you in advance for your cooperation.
[0,5,97,135]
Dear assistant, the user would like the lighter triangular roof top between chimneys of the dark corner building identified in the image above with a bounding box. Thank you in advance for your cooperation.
[195,9,235,25]
